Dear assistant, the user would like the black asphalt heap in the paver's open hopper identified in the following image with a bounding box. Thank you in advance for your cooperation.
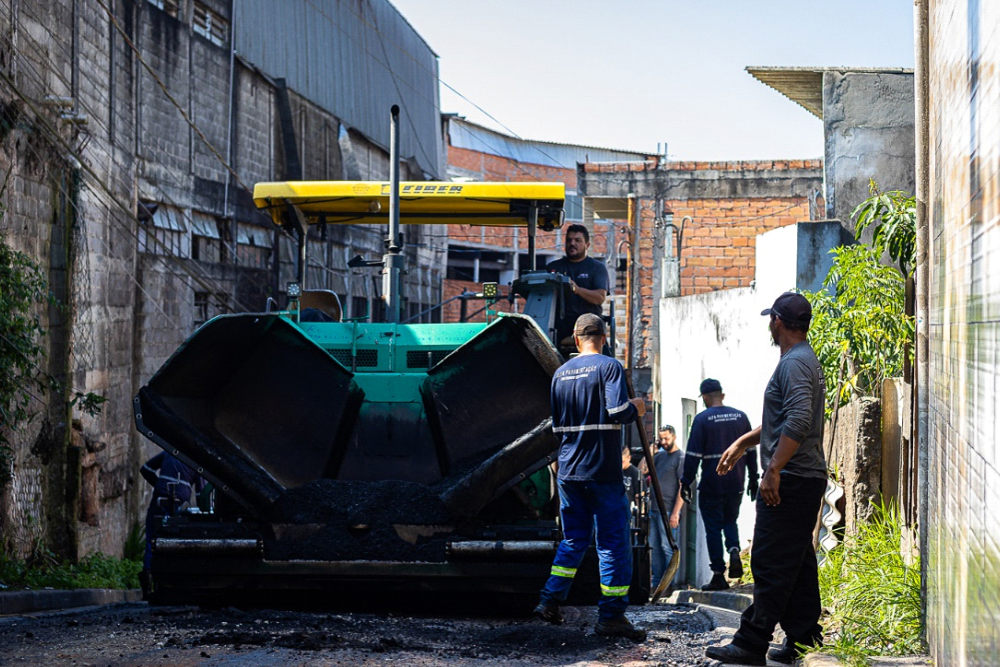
[264,479,452,562]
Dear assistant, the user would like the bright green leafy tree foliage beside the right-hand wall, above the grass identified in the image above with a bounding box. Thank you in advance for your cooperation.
[805,182,916,417]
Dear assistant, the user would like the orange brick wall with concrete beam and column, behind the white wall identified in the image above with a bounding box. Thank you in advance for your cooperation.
[579,160,823,368]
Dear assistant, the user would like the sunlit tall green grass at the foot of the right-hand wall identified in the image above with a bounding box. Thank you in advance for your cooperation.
[819,504,923,666]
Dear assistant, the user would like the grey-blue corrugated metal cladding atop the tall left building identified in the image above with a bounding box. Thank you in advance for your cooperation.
[233,0,443,178]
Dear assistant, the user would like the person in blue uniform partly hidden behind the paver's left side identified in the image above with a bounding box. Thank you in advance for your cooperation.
[139,452,205,599]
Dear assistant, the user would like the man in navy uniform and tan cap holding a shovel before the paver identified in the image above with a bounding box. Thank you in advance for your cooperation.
[535,313,646,642]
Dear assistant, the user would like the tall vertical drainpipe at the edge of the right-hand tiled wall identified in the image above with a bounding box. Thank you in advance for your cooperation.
[910,0,930,643]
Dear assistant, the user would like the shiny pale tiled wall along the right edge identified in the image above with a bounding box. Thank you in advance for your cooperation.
[924,0,1000,665]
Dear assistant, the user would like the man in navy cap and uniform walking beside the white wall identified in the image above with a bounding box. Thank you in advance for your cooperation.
[681,378,757,591]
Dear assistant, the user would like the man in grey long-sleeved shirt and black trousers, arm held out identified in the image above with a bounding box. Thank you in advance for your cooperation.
[705,292,827,665]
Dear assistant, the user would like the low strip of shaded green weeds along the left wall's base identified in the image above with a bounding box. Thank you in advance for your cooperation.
[0,554,142,590]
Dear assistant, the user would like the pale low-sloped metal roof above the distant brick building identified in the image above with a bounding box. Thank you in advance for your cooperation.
[448,116,653,171]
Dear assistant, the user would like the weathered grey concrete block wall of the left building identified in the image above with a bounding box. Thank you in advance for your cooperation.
[0,0,447,558]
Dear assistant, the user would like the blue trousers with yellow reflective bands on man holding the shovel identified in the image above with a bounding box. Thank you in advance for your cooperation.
[541,480,632,620]
